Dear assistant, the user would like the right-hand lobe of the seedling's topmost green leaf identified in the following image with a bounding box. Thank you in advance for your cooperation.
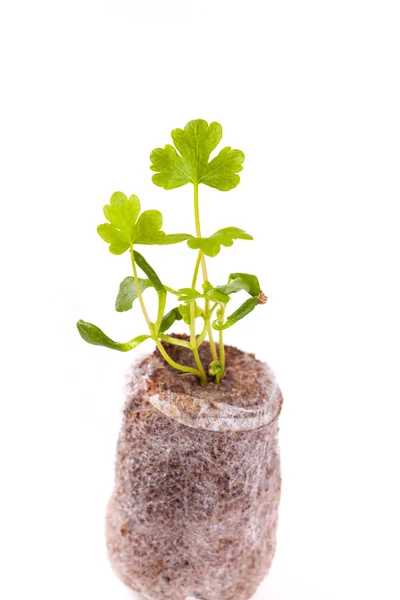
[201,146,245,192]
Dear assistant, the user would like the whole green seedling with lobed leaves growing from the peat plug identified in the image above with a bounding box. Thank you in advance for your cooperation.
[77,119,267,385]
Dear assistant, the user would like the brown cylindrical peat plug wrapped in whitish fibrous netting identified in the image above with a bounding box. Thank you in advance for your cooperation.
[107,344,282,600]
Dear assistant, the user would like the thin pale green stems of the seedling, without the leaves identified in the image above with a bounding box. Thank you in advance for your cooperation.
[130,184,225,385]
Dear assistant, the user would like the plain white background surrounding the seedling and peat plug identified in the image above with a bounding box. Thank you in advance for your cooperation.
[0,0,400,600]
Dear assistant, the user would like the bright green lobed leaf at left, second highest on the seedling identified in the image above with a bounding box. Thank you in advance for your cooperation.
[97,192,192,254]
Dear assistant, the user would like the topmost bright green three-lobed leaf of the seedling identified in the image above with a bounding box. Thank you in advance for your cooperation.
[150,119,244,191]
